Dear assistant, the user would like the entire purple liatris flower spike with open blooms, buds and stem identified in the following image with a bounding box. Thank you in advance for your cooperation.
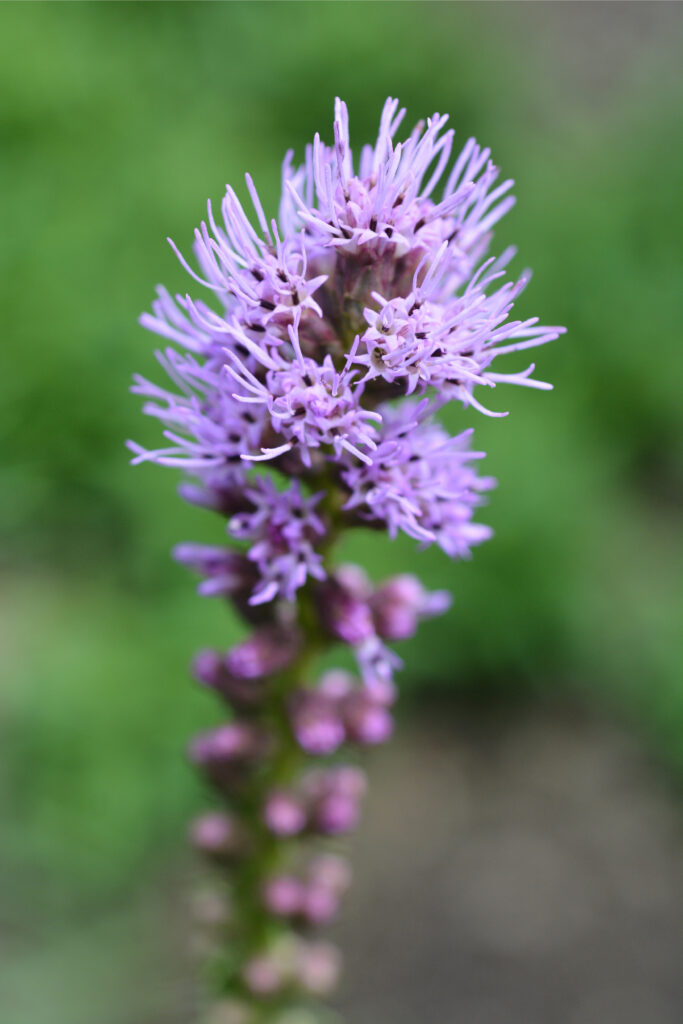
[130,99,562,1024]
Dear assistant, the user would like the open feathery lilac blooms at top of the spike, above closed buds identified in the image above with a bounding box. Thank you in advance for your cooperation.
[131,99,561,604]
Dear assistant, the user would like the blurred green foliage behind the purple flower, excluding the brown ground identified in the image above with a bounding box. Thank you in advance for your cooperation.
[0,2,683,1024]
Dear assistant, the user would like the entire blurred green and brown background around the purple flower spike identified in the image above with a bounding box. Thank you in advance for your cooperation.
[0,2,683,1024]
